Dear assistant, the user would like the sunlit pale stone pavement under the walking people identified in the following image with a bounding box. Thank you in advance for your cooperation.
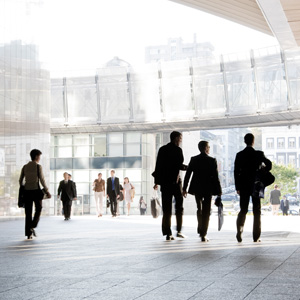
[0,216,300,300]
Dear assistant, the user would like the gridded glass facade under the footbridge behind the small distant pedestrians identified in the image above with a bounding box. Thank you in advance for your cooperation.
[50,132,156,214]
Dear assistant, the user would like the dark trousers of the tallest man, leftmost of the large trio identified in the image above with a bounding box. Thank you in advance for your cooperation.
[161,183,183,235]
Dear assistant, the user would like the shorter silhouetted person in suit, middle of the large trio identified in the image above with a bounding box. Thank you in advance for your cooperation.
[183,141,222,242]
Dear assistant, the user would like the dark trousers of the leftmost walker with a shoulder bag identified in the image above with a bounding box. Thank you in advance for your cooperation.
[25,190,43,236]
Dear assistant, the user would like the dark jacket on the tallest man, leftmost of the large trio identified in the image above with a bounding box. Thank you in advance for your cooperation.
[152,143,186,185]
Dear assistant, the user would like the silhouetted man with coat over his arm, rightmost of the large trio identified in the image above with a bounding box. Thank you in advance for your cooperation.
[234,133,272,243]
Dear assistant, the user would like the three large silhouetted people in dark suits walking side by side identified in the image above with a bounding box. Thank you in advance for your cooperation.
[152,131,272,242]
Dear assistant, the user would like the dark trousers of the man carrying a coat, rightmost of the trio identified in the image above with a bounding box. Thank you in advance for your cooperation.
[236,190,261,241]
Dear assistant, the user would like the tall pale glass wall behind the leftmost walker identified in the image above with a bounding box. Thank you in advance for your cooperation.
[0,0,51,216]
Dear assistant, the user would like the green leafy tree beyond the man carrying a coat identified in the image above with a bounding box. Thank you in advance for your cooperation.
[264,163,300,203]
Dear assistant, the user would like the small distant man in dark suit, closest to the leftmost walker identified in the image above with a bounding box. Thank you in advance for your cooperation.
[57,172,77,221]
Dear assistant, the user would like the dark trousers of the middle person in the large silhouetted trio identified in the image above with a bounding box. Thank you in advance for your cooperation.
[195,195,211,237]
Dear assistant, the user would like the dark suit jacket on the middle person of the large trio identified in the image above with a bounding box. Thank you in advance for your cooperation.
[183,153,222,196]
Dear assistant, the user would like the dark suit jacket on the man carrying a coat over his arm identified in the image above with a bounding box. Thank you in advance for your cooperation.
[234,146,272,193]
